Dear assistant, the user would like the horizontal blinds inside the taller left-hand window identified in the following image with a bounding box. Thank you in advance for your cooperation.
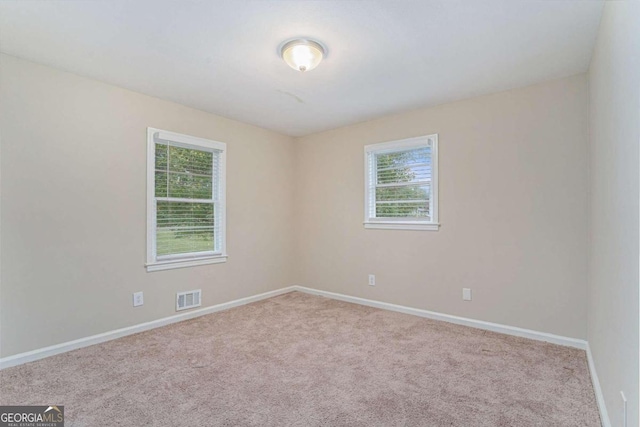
[154,140,221,260]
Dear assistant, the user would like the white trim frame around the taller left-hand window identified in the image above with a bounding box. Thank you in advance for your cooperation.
[145,128,228,272]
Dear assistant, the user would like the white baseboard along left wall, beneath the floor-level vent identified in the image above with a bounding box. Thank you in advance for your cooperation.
[0,286,296,369]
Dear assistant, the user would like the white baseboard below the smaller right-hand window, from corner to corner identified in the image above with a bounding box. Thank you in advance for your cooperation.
[292,286,587,350]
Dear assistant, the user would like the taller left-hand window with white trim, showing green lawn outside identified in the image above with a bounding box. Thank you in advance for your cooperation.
[147,128,227,271]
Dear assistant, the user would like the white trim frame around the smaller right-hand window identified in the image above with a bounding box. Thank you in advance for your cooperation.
[364,134,440,231]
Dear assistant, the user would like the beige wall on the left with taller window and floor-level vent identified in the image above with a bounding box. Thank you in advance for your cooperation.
[0,55,294,356]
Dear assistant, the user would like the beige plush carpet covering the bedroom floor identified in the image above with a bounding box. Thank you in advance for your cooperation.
[0,292,600,427]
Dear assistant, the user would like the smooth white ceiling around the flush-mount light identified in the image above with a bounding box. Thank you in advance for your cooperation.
[0,0,603,136]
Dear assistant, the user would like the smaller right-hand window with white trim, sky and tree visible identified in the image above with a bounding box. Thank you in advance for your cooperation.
[364,135,439,230]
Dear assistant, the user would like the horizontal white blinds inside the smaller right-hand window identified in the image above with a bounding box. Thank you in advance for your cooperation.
[369,145,432,221]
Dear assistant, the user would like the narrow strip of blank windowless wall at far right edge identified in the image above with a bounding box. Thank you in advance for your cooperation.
[588,1,640,427]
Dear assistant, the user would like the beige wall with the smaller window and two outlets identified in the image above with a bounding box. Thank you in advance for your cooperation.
[296,75,588,338]
